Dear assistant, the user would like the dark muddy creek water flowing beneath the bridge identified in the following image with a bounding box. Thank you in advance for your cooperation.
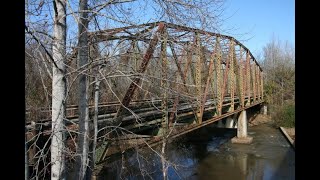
[97,124,295,180]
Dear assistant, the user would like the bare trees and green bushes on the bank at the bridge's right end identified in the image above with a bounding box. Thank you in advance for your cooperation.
[261,38,295,127]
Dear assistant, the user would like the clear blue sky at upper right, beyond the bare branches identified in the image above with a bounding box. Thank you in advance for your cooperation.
[222,0,295,57]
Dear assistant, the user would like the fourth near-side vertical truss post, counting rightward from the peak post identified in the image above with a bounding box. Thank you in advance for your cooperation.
[228,40,235,112]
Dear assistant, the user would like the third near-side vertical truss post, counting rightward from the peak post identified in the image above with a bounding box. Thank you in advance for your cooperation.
[216,37,223,116]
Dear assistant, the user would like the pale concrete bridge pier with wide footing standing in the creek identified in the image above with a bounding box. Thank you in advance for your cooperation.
[231,110,252,144]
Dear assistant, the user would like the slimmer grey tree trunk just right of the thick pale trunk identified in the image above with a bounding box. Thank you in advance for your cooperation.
[76,0,89,180]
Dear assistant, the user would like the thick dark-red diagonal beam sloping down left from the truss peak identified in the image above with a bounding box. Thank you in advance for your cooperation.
[116,23,165,123]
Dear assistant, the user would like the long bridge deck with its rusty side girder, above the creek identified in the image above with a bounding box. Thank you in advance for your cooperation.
[26,97,264,163]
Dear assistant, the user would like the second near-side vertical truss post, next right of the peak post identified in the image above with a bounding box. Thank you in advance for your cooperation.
[195,33,202,124]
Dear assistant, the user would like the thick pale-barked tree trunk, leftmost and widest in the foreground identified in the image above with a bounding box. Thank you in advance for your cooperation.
[51,0,67,180]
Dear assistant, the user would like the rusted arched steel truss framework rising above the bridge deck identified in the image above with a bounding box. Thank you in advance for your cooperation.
[26,22,264,167]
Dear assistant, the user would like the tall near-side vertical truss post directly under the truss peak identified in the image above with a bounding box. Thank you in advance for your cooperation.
[160,29,169,133]
